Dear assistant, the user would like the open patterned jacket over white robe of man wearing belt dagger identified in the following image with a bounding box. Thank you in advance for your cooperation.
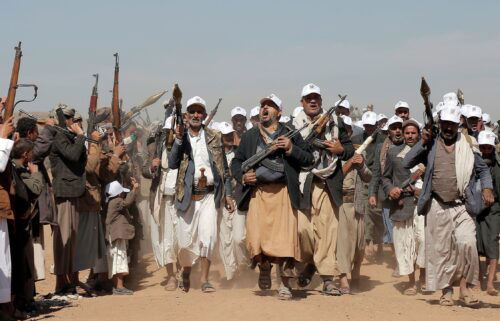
[168,127,232,212]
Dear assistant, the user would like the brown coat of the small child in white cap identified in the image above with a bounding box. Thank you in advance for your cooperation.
[106,190,136,242]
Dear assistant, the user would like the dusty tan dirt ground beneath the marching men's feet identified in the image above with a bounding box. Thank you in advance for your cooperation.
[32,224,500,321]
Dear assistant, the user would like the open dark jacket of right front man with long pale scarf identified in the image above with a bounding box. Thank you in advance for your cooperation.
[403,133,493,215]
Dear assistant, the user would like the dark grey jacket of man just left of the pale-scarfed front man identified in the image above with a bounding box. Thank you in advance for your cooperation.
[381,144,415,222]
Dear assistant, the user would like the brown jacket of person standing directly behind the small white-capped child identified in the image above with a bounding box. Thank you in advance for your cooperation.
[77,144,120,213]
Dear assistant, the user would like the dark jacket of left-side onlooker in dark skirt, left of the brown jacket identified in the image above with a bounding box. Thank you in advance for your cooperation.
[50,132,87,197]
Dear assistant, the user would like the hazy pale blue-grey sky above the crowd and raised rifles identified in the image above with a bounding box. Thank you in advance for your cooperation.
[0,0,500,120]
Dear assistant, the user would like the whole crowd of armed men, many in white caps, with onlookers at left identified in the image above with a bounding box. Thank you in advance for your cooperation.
[0,84,500,319]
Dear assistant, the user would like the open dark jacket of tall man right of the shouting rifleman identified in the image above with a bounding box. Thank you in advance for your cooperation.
[300,117,354,209]
